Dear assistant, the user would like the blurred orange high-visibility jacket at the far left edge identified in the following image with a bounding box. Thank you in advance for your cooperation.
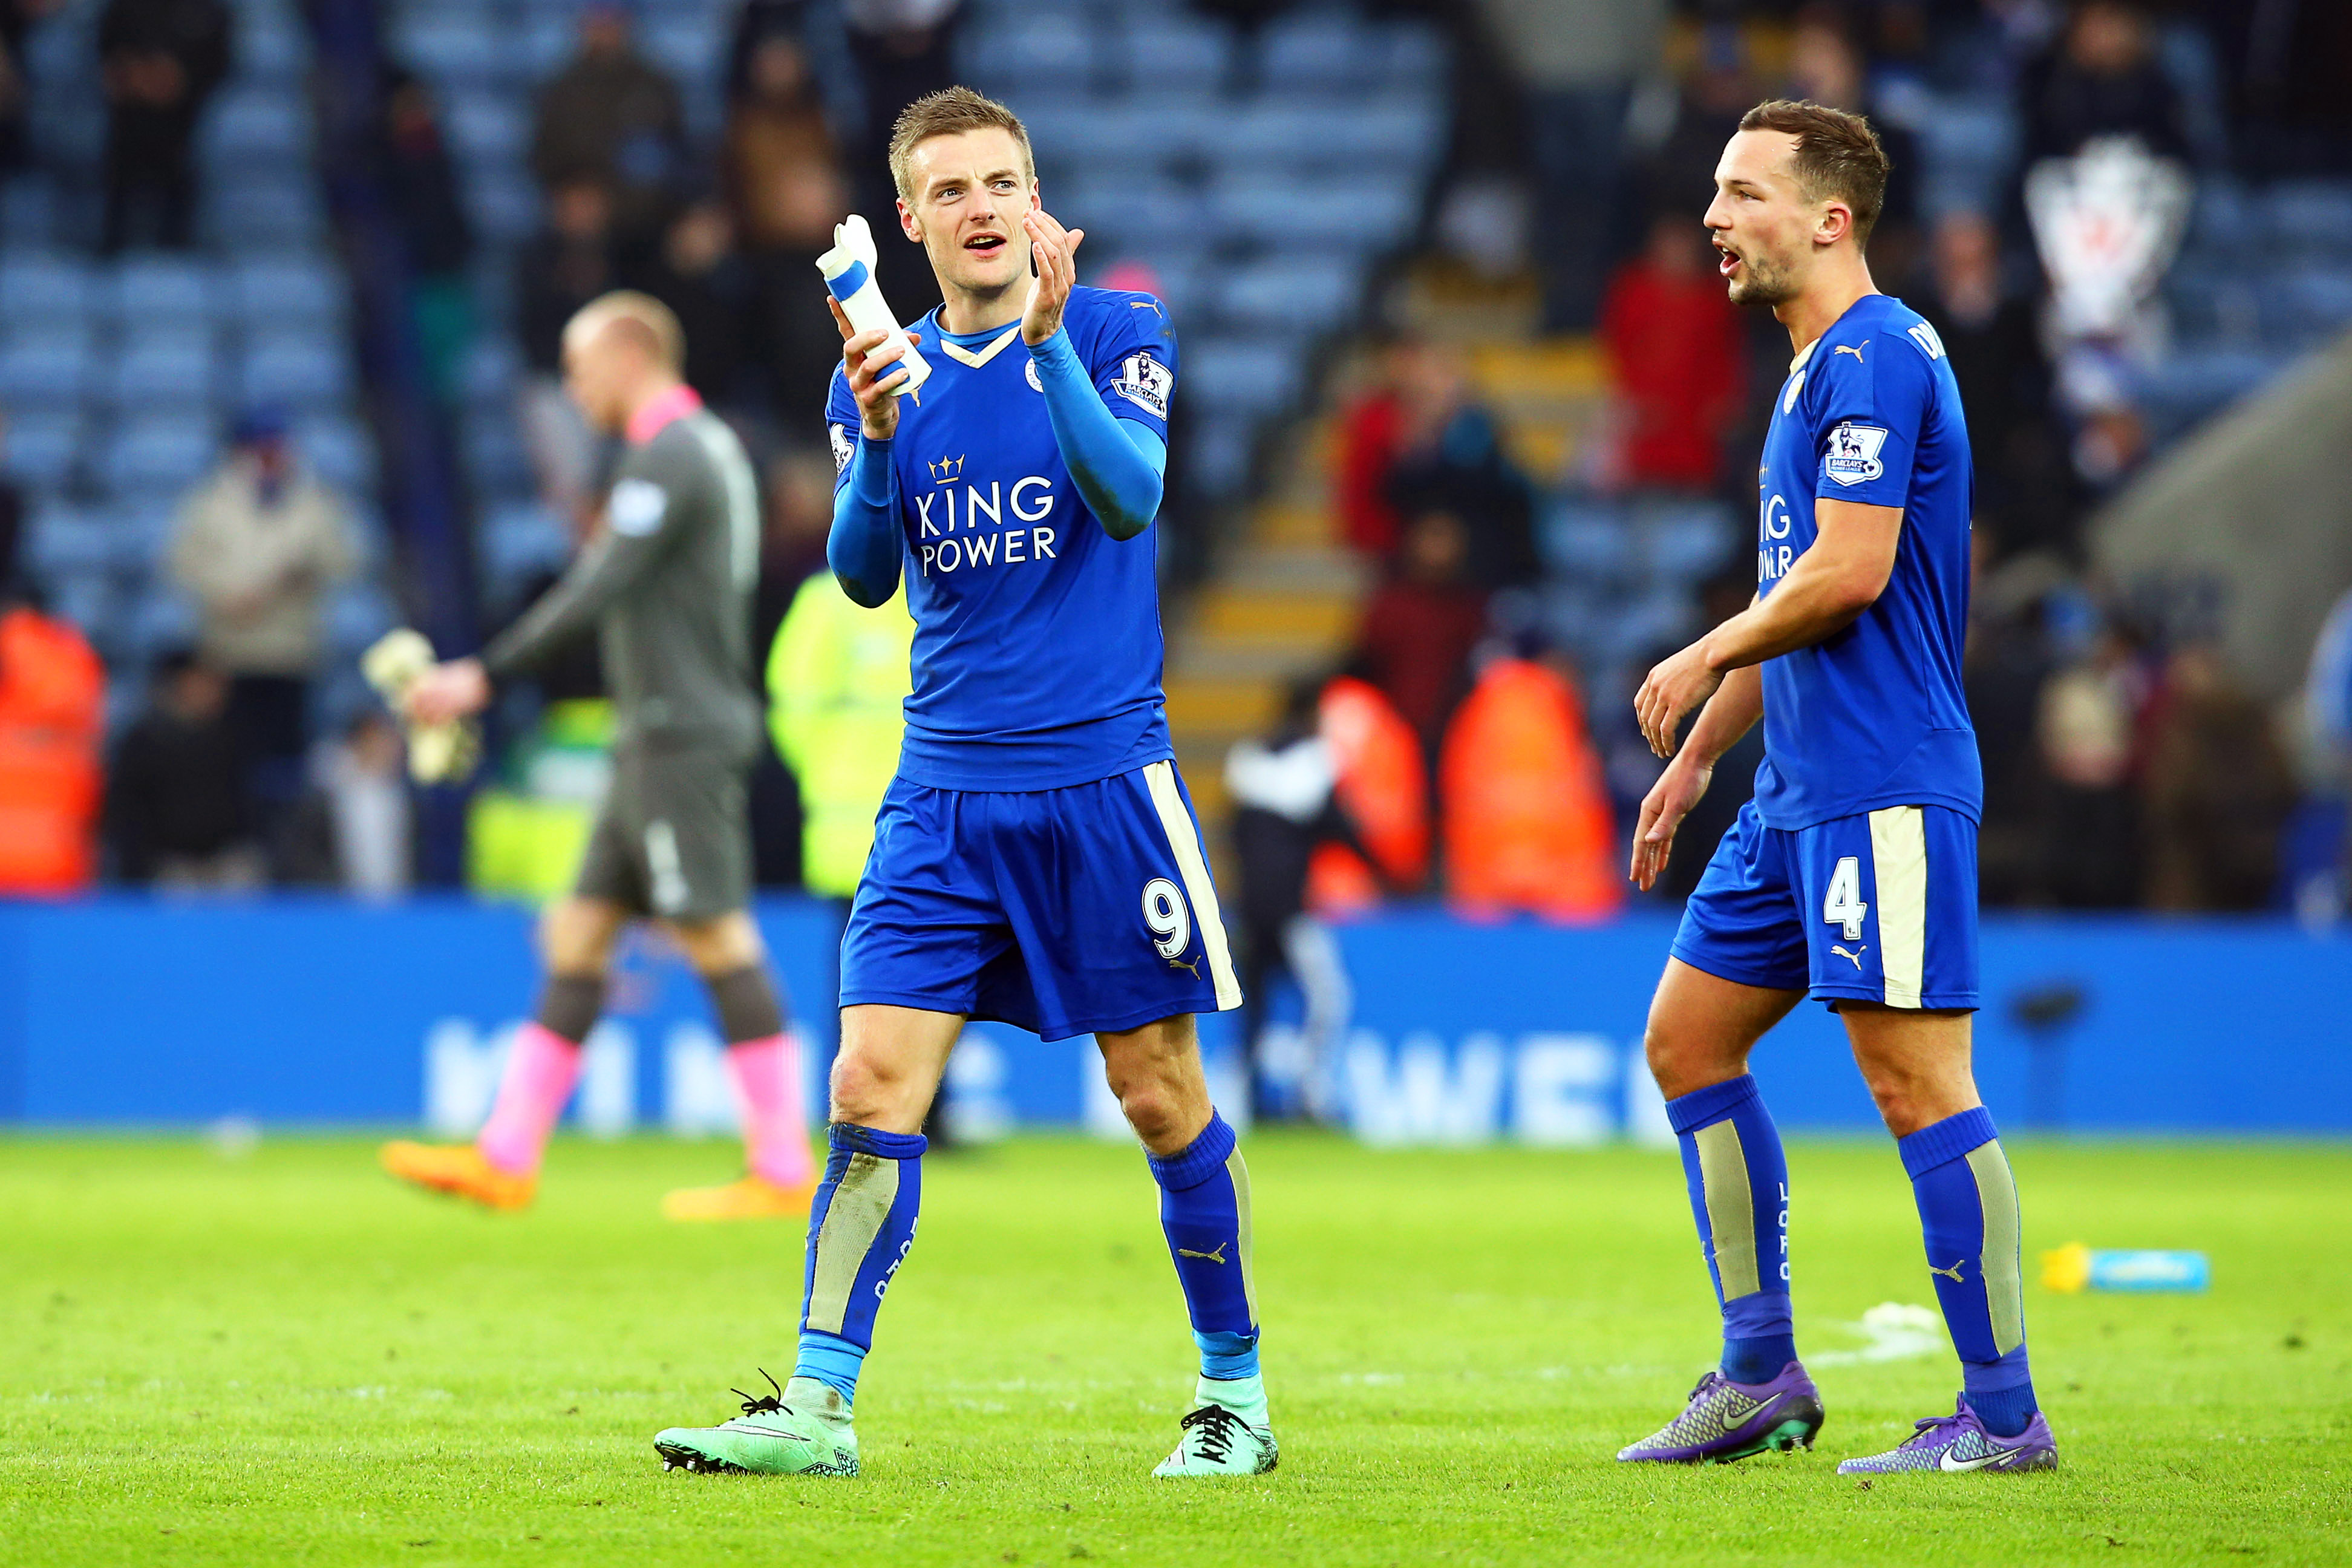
[0,607,106,893]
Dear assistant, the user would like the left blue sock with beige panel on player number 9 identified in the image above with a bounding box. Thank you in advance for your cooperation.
[792,1122,929,1403]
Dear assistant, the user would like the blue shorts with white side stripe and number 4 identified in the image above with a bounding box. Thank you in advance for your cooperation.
[1674,802,1976,1008]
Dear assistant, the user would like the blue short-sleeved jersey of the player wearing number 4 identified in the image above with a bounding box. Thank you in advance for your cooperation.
[1754,294,1985,830]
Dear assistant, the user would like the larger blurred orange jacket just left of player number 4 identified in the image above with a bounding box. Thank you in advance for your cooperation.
[1439,658,1625,919]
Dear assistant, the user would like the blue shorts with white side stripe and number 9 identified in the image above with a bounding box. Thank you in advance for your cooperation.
[842,762,1242,1039]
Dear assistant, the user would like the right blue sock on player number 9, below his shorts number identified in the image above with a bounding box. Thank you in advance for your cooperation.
[1150,1112,1263,1403]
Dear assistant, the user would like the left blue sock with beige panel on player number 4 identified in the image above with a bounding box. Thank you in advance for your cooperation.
[1665,1074,1797,1382]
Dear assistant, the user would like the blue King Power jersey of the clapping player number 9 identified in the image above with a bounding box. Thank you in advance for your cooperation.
[826,289,1176,790]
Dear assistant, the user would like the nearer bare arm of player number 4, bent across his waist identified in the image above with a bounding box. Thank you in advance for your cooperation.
[1635,501,1903,757]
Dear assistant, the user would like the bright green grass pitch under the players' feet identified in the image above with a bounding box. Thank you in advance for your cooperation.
[0,1135,2352,1568]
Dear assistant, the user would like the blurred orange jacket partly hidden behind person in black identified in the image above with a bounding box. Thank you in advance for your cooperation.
[1308,675,1430,915]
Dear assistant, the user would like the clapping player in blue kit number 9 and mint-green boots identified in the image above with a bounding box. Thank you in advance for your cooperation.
[654,87,1275,1476]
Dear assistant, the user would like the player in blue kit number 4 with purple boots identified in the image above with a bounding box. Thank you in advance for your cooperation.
[1618,101,2058,1474]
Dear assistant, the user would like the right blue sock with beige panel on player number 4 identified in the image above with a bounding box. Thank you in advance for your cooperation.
[1896,1107,2039,1436]
